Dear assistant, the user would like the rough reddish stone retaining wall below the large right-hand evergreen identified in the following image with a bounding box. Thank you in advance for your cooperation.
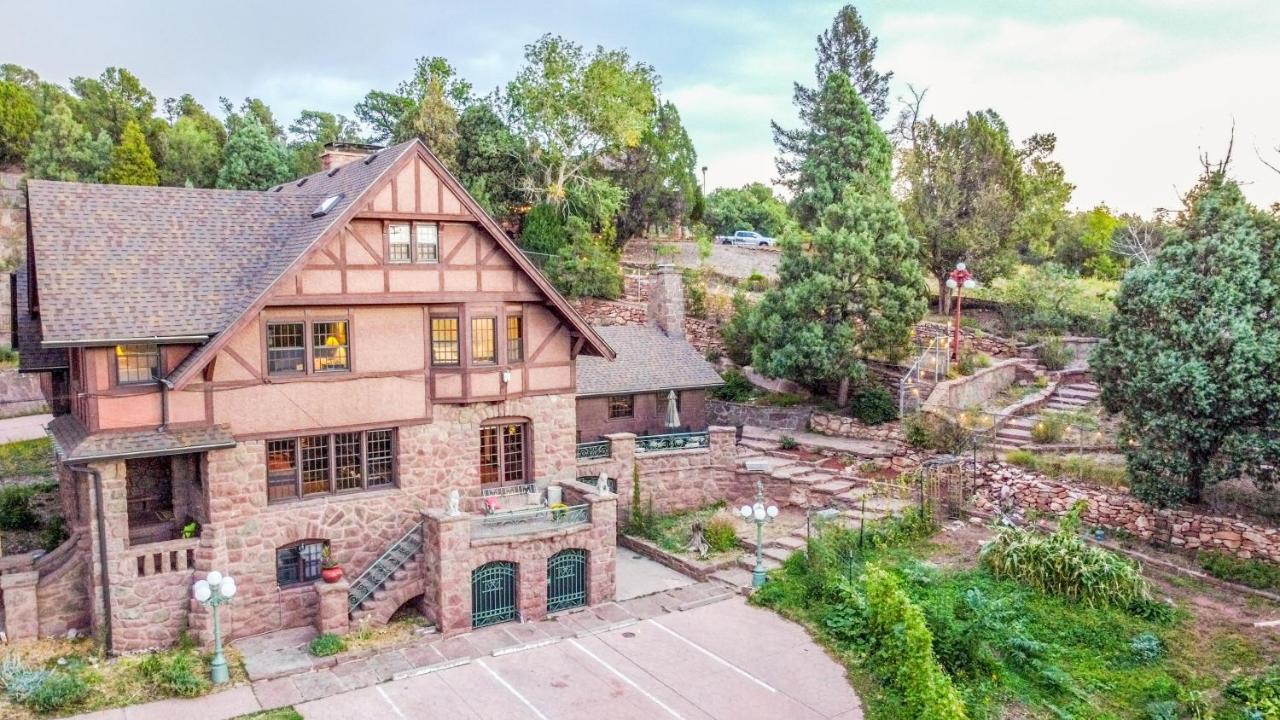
[975,462,1280,562]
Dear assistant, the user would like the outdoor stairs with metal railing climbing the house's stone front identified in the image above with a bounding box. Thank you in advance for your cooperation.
[347,523,426,625]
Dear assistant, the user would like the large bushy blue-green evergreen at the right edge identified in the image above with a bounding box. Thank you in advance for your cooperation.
[1091,168,1280,505]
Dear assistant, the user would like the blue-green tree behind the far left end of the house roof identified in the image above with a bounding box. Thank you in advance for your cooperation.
[27,102,111,182]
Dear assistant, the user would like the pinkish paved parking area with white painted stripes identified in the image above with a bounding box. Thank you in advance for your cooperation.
[297,597,863,720]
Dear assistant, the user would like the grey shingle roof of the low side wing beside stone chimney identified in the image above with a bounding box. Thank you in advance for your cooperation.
[577,325,724,397]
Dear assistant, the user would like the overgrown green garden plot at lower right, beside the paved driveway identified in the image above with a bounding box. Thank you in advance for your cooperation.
[753,512,1280,720]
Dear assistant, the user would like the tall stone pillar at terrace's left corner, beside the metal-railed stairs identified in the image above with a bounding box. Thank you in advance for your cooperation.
[424,510,471,637]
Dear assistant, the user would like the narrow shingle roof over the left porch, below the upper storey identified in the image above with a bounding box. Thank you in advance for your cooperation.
[49,415,236,462]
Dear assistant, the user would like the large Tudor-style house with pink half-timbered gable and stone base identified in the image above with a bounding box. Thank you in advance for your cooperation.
[5,141,616,650]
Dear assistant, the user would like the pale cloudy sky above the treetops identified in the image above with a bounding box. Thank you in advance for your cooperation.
[10,0,1280,214]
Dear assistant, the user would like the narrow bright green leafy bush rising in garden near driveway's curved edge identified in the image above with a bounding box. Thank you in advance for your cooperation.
[865,565,968,720]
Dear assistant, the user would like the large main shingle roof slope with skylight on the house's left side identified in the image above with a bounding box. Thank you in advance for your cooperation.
[27,142,413,343]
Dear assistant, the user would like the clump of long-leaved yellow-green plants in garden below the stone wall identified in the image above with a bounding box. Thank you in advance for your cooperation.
[979,501,1152,612]
